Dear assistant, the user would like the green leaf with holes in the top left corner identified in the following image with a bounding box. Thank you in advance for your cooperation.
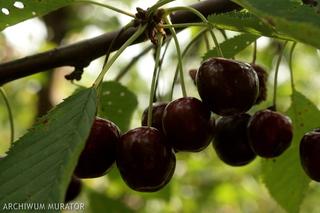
[0,0,75,31]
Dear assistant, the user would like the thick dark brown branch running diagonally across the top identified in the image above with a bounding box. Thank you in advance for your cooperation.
[0,0,240,85]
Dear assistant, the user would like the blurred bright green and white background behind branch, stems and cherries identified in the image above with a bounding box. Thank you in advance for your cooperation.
[0,0,320,213]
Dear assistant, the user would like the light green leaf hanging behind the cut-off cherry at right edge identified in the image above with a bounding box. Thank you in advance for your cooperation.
[262,91,320,213]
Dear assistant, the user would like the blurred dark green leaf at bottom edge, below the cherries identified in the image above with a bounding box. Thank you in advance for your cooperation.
[88,190,135,213]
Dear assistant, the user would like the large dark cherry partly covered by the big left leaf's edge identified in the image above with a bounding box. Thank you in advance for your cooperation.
[74,117,120,178]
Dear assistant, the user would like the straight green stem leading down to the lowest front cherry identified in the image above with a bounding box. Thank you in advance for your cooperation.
[147,33,163,127]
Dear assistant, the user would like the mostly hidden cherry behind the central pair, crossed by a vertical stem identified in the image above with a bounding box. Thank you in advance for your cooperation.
[141,102,168,133]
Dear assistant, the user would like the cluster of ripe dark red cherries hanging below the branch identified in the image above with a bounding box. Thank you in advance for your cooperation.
[66,58,320,202]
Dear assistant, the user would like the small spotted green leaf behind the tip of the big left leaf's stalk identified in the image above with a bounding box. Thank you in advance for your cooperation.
[98,81,138,132]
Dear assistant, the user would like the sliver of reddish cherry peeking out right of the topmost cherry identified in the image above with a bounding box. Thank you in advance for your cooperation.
[251,64,268,104]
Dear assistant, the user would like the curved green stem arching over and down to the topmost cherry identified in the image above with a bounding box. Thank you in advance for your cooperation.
[166,6,223,57]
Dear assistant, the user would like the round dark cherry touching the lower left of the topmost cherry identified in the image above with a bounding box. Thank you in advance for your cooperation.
[162,97,214,152]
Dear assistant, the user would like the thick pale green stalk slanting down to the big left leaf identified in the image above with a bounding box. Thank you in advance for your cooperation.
[93,25,146,88]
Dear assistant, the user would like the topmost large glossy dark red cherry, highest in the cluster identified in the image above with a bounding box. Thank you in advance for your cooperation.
[196,58,259,116]
